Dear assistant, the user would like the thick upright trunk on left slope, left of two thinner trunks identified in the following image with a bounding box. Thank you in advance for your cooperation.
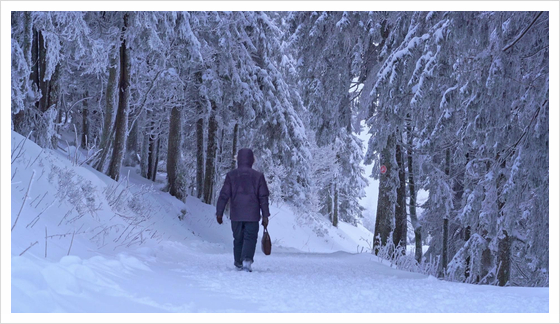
[167,107,184,199]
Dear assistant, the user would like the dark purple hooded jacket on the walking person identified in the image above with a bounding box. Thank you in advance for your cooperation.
[216,148,270,222]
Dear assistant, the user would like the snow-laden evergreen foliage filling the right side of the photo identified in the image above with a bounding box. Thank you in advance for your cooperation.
[361,12,549,285]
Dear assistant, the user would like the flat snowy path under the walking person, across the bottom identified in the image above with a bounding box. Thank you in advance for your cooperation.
[12,242,548,313]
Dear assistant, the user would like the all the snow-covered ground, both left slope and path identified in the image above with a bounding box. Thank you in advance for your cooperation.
[2,132,558,323]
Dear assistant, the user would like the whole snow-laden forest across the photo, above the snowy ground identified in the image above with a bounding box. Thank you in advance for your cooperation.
[11,11,549,286]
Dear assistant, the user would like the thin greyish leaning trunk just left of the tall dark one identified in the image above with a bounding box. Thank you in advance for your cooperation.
[95,49,119,172]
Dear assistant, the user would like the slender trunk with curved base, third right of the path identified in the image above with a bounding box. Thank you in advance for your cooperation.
[406,114,422,263]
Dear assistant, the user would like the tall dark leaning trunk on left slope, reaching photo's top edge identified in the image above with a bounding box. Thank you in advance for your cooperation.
[108,14,130,180]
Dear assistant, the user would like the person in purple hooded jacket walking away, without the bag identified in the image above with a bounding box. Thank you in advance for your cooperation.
[216,148,270,272]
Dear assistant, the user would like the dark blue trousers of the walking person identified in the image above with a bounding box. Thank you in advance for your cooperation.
[231,221,259,265]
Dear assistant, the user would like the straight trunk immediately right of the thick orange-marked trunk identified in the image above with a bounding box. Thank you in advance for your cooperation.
[393,140,407,254]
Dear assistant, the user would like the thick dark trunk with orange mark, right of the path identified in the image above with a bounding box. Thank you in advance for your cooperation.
[374,134,395,255]
